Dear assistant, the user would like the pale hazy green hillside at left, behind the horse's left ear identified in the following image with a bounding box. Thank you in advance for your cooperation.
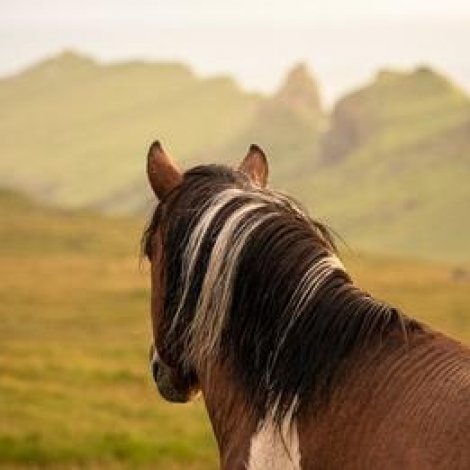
[0,52,259,210]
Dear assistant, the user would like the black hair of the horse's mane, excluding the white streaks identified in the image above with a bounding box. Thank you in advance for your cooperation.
[142,165,420,423]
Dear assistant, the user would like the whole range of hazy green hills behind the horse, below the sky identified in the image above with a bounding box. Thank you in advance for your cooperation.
[0,52,470,261]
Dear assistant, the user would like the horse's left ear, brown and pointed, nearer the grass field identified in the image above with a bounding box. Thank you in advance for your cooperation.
[147,140,183,199]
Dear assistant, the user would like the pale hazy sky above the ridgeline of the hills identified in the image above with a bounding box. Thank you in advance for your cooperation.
[0,0,470,102]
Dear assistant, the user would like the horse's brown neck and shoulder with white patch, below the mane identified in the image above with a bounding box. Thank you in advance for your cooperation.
[202,333,470,470]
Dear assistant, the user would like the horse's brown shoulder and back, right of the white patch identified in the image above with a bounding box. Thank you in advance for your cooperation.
[298,332,470,469]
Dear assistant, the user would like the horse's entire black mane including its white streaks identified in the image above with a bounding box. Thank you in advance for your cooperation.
[142,165,420,422]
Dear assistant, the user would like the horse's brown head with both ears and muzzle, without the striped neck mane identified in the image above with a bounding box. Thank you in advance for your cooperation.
[144,142,268,402]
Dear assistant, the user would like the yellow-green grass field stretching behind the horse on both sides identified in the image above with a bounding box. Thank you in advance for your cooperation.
[0,193,470,469]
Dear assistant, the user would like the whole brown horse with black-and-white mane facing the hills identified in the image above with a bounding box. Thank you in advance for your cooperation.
[142,141,470,470]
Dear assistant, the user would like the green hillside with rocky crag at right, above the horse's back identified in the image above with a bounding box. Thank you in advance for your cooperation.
[298,68,470,262]
